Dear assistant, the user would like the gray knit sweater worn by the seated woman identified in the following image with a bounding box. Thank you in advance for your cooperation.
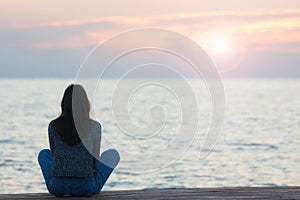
[48,120,101,178]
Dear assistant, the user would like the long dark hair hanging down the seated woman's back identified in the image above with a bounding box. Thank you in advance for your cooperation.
[54,84,90,146]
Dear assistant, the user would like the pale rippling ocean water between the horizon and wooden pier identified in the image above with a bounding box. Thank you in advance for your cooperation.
[0,79,300,193]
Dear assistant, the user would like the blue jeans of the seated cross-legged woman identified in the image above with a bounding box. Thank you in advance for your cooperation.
[38,149,120,196]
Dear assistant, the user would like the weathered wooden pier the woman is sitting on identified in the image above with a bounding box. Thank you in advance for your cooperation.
[0,187,300,200]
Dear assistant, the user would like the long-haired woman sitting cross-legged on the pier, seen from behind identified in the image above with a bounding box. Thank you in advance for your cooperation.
[38,85,120,196]
